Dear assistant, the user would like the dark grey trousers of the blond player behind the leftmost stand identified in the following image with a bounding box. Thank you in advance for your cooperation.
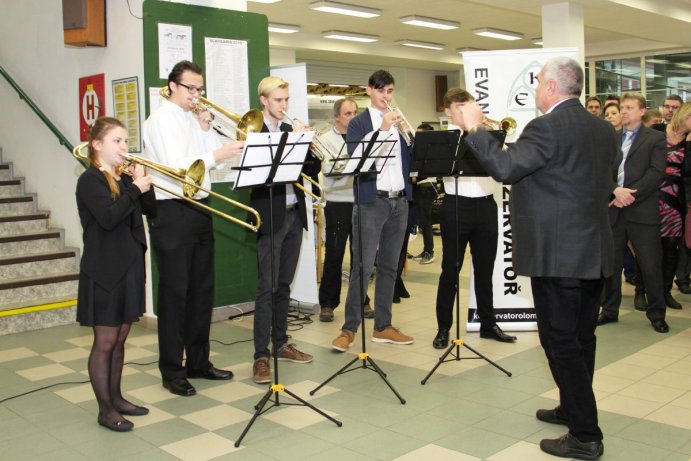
[254,208,302,360]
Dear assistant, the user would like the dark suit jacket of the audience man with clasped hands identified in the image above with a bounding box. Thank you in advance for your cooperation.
[609,125,667,226]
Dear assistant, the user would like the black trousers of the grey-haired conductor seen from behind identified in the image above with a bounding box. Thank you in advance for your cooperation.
[531,276,604,442]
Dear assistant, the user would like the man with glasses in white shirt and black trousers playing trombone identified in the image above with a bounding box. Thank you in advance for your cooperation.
[143,61,244,396]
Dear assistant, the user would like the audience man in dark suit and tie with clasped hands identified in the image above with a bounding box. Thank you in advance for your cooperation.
[597,93,669,333]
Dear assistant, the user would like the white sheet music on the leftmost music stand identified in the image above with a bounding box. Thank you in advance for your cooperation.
[233,131,314,189]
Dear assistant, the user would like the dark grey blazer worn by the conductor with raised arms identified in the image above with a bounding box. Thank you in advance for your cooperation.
[466,98,617,279]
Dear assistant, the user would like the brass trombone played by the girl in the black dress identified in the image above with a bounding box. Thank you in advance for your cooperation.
[72,142,262,232]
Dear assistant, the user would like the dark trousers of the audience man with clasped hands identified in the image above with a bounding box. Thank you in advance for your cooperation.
[602,216,666,320]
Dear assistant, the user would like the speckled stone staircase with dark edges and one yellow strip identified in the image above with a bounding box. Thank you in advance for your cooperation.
[0,149,79,335]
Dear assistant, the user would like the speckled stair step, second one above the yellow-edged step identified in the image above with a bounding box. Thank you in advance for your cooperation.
[0,249,78,281]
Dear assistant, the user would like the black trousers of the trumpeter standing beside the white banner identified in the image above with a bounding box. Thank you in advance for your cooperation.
[437,194,498,330]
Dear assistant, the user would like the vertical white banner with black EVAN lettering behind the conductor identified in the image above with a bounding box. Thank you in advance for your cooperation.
[463,48,578,331]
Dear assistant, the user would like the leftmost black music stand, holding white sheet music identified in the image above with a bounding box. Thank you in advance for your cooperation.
[235,132,343,448]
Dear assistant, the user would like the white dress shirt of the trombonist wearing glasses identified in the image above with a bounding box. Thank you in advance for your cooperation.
[144,99,221,200]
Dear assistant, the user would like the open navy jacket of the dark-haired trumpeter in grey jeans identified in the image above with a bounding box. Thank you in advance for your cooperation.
[346,109,413,203]
